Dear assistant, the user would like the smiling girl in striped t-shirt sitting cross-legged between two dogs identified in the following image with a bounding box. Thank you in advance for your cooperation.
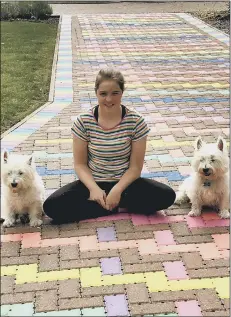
[44,69,175,223]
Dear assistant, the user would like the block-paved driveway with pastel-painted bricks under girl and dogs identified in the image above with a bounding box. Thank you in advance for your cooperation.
[1,13,229,316]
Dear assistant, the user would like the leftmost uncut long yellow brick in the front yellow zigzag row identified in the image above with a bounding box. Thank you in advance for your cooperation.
[37,269,80,282]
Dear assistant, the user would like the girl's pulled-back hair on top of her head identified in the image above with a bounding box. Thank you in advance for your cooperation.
[95,68,125,93]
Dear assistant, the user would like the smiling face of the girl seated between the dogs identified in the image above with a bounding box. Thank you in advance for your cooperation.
[96,80,123,109]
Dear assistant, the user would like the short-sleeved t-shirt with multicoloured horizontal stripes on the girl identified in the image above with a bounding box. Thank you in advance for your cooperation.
[71,107,150,182]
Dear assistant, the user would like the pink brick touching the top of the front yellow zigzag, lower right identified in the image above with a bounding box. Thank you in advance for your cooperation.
[163,261,188,280]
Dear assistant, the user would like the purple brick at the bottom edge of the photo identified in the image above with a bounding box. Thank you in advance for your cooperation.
[104,294,130,316]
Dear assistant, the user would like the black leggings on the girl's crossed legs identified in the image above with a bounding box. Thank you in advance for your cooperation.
[43,178,176,223]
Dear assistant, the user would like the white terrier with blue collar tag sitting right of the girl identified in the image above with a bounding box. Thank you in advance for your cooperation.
[175,137,229,218]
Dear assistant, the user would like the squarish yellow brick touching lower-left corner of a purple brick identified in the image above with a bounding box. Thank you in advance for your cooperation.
[80,267,102,287]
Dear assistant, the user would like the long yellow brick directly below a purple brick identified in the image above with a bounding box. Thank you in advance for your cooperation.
[102,273,145,286]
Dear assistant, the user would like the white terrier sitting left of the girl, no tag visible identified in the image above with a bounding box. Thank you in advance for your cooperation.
[1,150,45,227]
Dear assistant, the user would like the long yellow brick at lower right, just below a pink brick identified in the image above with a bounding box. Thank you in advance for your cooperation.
[168,278,214,291]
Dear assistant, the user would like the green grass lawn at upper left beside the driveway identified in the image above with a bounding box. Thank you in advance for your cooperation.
[1,21,58,133]
